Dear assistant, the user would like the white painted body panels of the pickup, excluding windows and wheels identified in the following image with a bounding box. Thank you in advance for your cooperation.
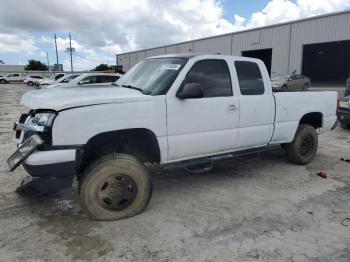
[22,55,337,163]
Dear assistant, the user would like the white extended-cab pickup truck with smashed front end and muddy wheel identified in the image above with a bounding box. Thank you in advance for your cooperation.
[7,54,337,220]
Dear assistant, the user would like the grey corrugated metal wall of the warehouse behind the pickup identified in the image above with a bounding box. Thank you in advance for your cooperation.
[117,12,350,75]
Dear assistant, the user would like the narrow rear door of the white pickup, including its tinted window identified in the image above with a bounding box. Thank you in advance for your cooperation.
[234,61,275,149]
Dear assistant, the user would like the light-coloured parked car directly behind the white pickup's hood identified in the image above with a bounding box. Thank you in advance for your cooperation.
[45,73,121,88]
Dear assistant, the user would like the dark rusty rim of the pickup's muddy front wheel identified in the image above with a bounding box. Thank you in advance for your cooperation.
[97,174,137,211]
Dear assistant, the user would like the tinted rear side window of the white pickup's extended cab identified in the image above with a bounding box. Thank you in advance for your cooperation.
[235,61,265,95]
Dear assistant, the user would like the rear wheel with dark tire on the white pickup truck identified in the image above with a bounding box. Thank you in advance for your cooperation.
[286,124,318,165]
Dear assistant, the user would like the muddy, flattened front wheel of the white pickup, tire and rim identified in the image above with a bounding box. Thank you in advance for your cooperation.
[79,154,152,220]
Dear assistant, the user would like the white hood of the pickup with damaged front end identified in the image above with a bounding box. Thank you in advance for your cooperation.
[21,86,151,111]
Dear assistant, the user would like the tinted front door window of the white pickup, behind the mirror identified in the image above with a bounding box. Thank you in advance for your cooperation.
[183,59,232,97]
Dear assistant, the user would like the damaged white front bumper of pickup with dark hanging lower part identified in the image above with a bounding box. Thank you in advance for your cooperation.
[16,149,77,195]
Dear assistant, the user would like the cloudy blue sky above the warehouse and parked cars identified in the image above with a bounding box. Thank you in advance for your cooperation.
[0,0,350,70]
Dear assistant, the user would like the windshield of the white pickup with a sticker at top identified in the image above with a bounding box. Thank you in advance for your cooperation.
[116,58,187,95]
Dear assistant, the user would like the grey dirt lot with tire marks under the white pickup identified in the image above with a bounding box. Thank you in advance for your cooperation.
[0,84,350,262]
